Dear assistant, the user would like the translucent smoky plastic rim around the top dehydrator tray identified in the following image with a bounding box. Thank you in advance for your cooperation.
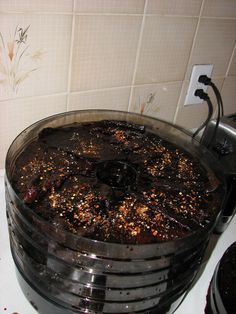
[5,109,225,250]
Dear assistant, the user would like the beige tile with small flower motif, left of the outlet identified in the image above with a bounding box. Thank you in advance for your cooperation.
[129,82,182,122]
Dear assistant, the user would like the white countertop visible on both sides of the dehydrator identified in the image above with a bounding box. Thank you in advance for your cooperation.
[0,170,236,314]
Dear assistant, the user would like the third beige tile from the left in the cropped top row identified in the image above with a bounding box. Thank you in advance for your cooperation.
[147,0,202,15]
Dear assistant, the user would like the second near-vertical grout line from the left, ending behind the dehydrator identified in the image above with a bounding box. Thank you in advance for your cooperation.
[128,0,148,111]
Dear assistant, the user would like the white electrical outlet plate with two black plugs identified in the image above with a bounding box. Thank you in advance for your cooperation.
[184,64,213,106]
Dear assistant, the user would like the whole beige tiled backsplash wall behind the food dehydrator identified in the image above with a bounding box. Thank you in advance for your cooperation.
[0,0,236,168]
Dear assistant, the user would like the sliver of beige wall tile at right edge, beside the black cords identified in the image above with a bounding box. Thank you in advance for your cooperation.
[221,76,236,115]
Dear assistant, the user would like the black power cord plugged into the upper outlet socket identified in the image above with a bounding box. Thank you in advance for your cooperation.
[198,75,224,148]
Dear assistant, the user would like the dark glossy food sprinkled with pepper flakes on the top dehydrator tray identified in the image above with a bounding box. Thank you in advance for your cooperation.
[13,120,215,244]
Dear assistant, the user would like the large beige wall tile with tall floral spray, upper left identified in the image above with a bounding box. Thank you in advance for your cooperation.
[0,14,72,100]
